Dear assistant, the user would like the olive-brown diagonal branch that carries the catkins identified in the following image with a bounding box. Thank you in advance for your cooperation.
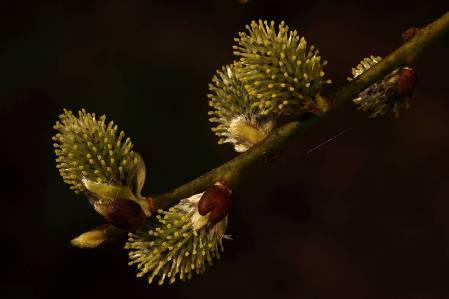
[73,12,449,247]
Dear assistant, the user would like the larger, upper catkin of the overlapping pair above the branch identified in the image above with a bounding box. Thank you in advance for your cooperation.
[233,20,331,115]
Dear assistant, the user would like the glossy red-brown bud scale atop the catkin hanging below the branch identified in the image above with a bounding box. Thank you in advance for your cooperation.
[198,183,232,223]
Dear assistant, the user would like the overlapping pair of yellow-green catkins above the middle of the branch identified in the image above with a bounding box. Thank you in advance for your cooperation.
[208,20,331,152]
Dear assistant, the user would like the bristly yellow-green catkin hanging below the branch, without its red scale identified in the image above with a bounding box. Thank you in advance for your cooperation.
[125,188,231,284]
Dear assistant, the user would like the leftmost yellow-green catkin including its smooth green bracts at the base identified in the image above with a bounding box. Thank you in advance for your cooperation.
[53,109,150,215]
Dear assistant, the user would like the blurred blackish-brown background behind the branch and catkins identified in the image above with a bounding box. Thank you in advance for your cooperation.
[0,0,449,299]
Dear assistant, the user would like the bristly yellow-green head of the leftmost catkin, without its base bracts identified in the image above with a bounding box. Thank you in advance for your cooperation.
[53,109,139,192]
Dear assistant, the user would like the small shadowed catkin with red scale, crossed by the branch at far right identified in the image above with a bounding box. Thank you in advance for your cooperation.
[348,56,416,117]
